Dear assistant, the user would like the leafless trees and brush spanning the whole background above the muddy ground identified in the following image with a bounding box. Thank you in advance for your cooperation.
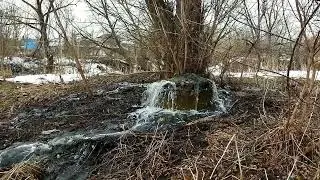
[0,0,319,75]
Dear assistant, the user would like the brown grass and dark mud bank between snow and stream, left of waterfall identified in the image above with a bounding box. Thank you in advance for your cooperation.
[0,73,159,150]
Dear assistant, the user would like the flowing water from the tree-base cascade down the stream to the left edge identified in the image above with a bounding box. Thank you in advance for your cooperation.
[0,81,229,179]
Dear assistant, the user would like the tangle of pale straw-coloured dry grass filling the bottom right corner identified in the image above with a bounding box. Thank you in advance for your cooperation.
[174,87,320,180]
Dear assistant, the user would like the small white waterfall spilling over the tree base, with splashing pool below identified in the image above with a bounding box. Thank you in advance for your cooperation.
[130,80,227,131]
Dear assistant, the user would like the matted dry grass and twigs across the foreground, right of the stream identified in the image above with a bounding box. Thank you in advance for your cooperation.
[92,116,320,180]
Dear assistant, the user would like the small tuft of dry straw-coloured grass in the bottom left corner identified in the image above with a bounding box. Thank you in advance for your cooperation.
[0,162,43,180]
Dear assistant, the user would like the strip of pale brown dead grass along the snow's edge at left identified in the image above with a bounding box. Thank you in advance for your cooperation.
[0,72,161,121]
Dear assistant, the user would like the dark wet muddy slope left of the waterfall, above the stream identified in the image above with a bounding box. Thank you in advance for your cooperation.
[0,83,145,149]
